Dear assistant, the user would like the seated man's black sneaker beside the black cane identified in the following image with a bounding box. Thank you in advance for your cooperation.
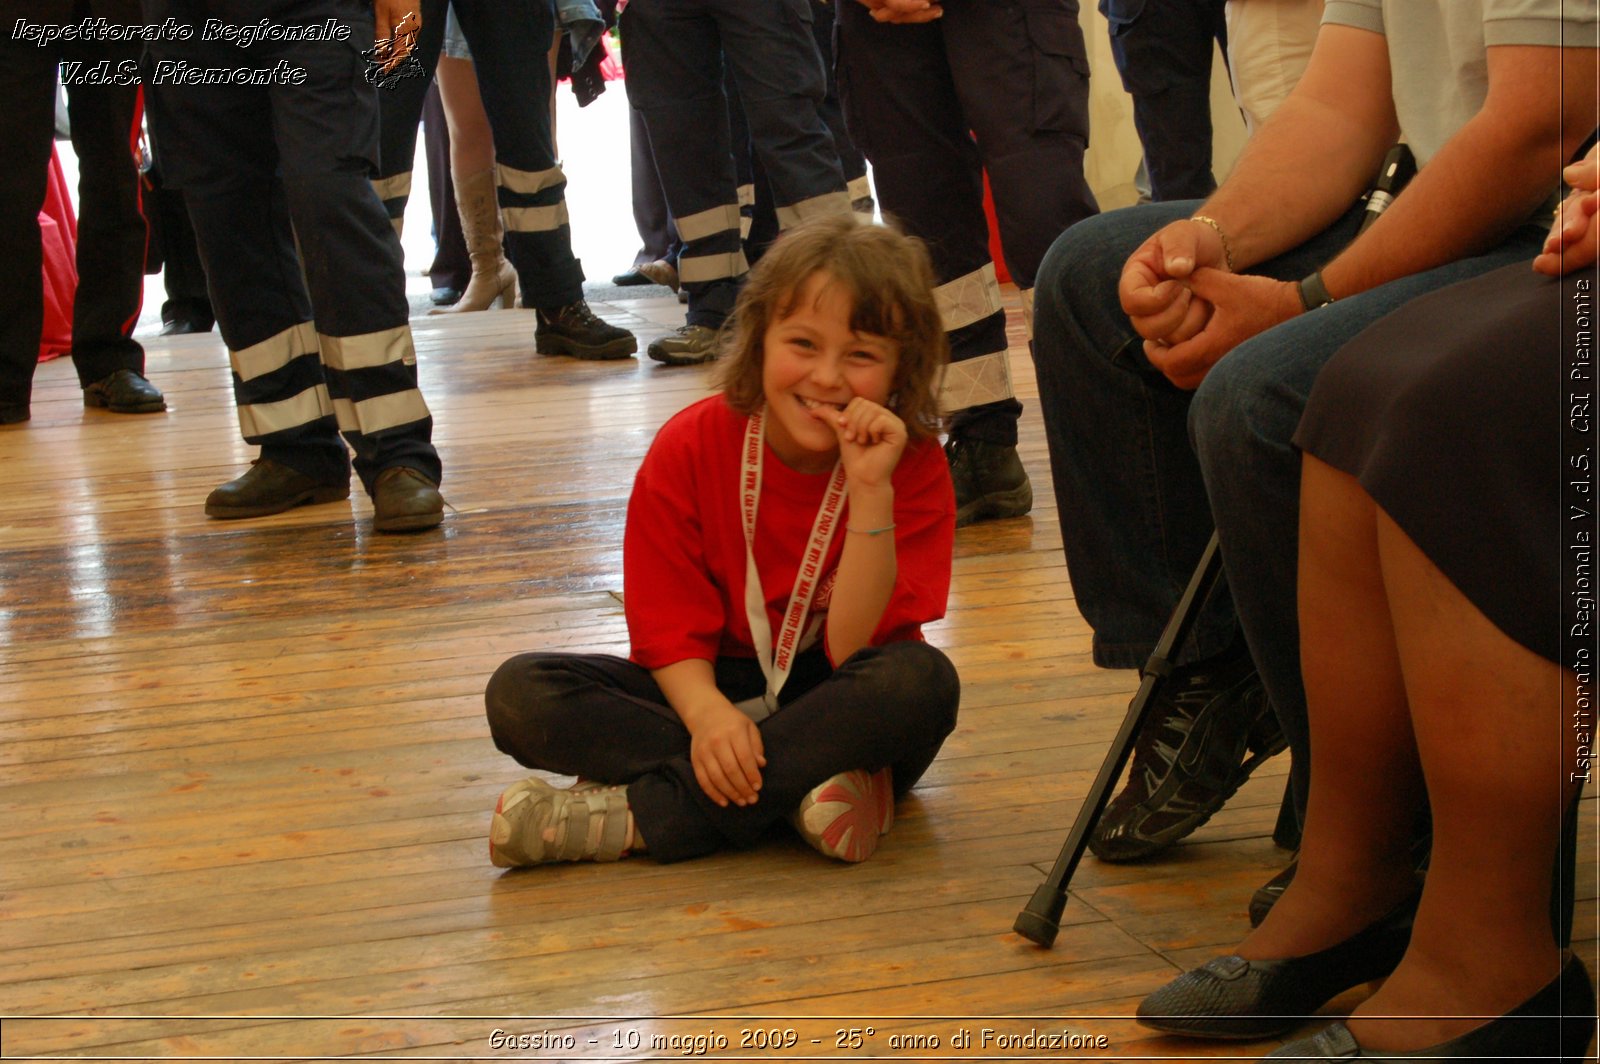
[1090,651,1288,861]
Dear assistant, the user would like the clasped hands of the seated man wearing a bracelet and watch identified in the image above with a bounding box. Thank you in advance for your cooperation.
[1117,219,1301,390]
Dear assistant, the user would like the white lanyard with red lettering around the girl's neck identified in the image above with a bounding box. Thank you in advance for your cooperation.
[738,410,845,720]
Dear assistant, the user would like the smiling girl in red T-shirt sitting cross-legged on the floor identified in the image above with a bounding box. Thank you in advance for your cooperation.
[486,216,960,867]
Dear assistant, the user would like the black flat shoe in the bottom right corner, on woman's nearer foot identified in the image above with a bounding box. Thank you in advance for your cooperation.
[1266,957,1595,1064]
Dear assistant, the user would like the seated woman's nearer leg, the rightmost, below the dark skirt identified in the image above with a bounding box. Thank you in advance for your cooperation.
[1344,510,1581,1050]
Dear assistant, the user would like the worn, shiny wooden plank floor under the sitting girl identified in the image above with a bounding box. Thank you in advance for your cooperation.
[0,286,1597,1059]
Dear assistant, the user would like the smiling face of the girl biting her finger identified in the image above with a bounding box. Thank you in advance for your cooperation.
[762,270,899,474]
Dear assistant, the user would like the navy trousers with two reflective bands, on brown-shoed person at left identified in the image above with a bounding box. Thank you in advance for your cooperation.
[144,0,440,493]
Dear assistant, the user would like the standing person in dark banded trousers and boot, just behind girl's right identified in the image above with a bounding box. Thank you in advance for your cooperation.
[838,0,1099,526]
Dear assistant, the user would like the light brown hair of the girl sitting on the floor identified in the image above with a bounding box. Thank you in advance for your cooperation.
[717,214,950,440]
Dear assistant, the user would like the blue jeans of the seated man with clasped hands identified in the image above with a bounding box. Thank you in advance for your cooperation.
[1034,200,1544,813]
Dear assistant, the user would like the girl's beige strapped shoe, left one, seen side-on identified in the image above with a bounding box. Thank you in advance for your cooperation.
[490,779,634,869]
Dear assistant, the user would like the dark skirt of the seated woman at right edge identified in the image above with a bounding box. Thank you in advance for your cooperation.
[1294,262,1595,661]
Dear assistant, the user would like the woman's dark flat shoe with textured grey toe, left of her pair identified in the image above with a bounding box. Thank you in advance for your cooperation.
[1136,899,1416,1038]
